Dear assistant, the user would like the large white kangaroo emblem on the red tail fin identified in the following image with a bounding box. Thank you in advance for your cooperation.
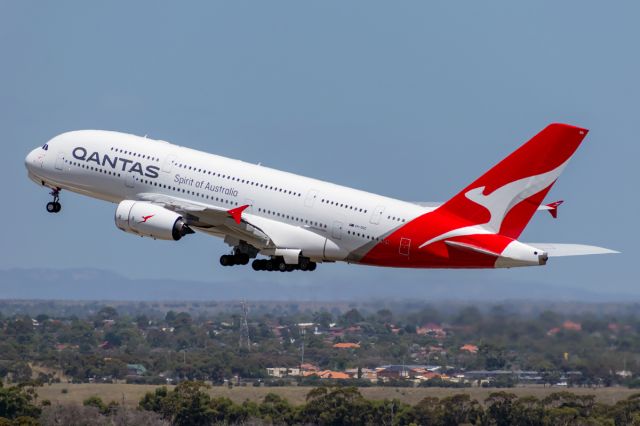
[419,160,569,248]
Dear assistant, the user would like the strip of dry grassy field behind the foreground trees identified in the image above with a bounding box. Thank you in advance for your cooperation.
[38,383,638,406]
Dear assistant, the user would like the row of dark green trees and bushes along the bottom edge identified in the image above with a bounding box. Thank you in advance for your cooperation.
[0,381,640,426]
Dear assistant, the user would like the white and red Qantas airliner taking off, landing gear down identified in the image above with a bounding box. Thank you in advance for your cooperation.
[25,124,614,272]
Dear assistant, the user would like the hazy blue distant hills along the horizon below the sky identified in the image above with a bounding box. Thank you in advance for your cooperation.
[0,269,640,302]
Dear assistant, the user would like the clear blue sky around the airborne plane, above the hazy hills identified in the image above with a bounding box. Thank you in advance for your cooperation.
[0,1,640,297]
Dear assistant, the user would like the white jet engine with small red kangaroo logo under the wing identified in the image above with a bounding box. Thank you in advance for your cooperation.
[115,200,193,241]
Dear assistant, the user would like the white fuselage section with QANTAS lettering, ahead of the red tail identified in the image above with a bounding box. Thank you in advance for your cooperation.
[26,130,432,262]
